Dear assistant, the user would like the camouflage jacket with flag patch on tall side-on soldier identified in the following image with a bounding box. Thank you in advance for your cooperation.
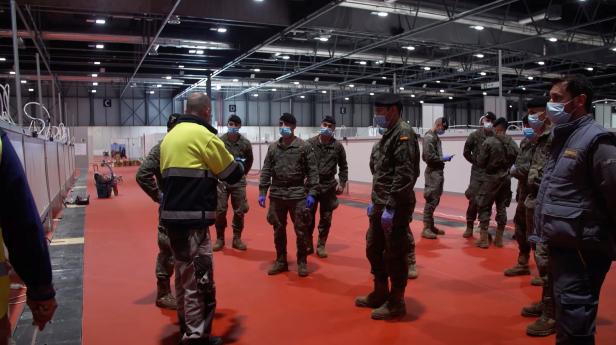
[370,120,420,211]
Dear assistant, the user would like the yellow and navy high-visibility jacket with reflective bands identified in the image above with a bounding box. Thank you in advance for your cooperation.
[160,115,244,229]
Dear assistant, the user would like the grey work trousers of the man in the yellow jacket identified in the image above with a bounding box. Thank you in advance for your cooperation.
[169,228,216,343]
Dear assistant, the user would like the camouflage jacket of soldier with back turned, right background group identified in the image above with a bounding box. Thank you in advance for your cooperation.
[477,134,520,176]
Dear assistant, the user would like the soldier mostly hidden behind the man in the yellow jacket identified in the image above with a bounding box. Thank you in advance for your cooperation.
[136,114,180,310]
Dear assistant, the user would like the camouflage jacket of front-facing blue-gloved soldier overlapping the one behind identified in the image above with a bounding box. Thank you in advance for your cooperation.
[259,137,319,200]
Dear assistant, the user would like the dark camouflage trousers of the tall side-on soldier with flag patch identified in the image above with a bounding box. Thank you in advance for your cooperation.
[366,205,414,293]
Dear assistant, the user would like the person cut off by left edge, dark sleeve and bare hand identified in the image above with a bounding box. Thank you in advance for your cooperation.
[0,129,57,345]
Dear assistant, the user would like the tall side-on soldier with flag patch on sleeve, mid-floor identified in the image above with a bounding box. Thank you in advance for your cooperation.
[355,94,420,320]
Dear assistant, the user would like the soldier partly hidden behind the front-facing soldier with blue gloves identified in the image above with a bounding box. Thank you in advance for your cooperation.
[306,116,349,258]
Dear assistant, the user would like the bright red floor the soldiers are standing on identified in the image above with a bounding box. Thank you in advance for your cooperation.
[83,168,616,345]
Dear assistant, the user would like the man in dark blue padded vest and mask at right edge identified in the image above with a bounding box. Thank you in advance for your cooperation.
[535,75,616,345]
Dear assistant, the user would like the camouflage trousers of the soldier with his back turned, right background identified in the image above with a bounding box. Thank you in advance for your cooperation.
[475,175,512,229]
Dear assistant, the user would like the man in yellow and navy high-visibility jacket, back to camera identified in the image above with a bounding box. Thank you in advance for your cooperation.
[160,93,244,345]
